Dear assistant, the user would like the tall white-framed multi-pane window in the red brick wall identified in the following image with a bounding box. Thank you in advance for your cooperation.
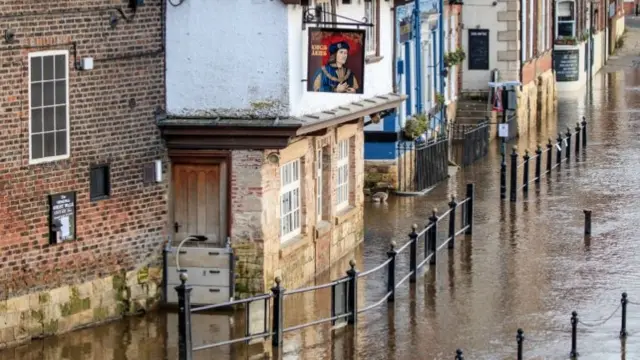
[29,50,69,163]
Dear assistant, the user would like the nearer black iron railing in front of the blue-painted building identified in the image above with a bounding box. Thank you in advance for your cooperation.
[396,136,449,193]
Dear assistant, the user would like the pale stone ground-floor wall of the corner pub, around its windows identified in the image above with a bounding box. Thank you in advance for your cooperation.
[231,119,364,297]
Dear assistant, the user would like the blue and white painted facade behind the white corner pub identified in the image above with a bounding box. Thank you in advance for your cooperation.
[364,0,446,160]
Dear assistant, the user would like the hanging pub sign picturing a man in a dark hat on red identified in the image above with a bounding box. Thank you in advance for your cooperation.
[307,28,365,94]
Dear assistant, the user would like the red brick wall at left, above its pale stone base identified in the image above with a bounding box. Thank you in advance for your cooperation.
[0,0,166,299]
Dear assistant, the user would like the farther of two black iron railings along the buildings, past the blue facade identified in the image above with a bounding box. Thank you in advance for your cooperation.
[453,121,489,166]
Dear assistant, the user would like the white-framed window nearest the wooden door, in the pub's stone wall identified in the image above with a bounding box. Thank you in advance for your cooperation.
[280,159,301,242]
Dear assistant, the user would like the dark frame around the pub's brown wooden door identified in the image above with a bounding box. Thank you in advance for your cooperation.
[167,149,232,243]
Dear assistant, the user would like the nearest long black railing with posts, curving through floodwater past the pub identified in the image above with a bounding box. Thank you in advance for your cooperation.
[175,184,474,360]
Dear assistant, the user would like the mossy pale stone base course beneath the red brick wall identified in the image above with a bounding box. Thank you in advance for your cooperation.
[0,267,162,349]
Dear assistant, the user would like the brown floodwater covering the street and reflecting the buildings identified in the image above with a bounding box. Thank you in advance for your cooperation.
[6,24,640,360]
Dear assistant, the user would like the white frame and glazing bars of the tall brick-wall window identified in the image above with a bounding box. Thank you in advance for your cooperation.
[27,50,71,164]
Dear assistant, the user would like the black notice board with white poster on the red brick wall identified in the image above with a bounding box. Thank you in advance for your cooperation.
[49,191,76,244]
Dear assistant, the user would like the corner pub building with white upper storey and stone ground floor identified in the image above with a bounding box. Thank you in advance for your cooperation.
[158,0,404,302]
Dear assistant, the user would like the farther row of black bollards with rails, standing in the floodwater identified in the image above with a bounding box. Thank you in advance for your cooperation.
[500,117,587,201]
